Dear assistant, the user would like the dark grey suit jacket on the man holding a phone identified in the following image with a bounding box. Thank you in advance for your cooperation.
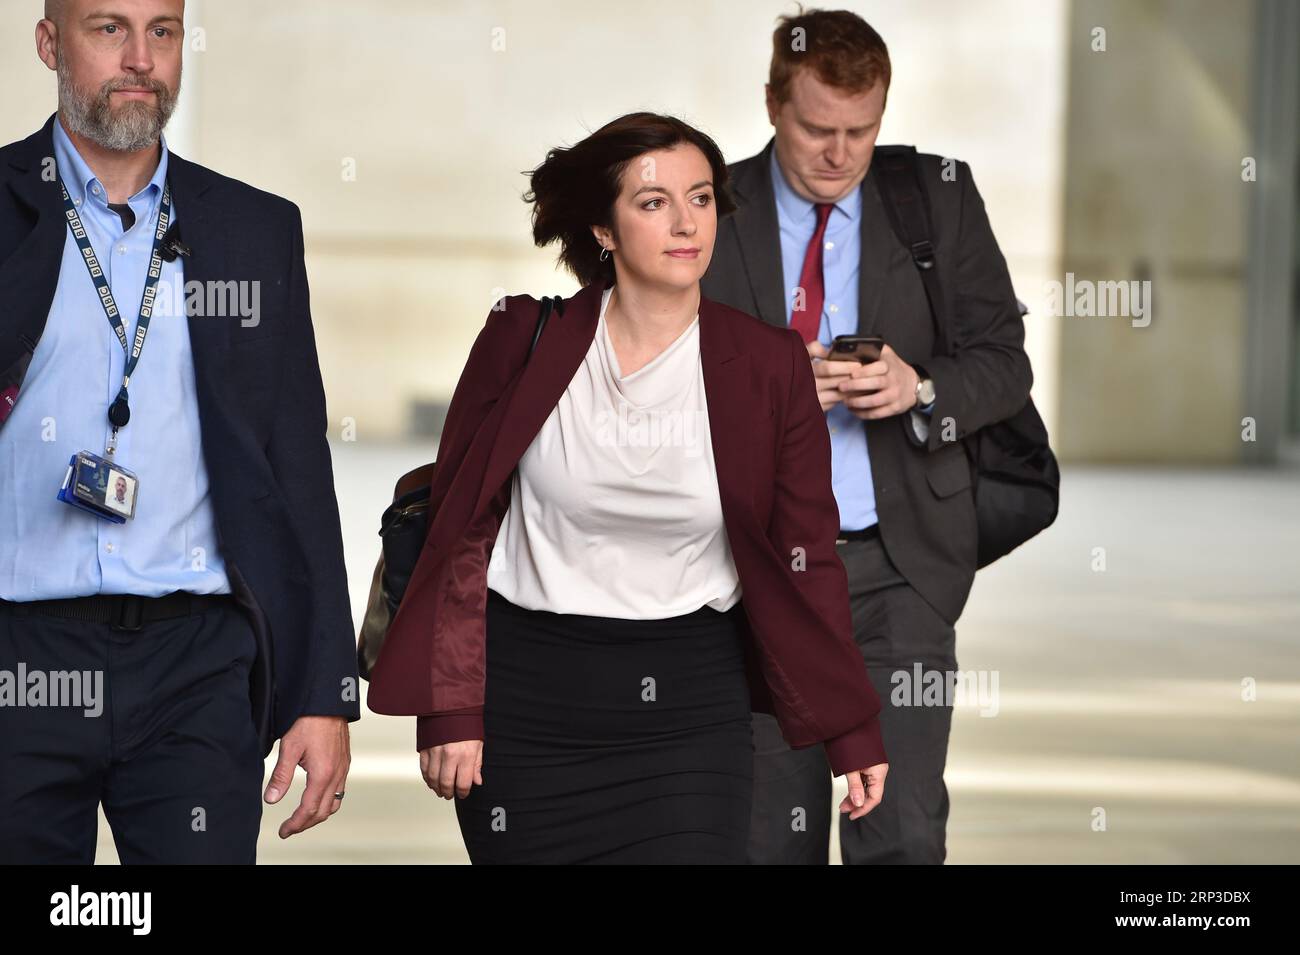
[702,139,1032,622]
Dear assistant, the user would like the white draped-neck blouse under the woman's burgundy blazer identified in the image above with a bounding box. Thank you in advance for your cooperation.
[488,287,741,620]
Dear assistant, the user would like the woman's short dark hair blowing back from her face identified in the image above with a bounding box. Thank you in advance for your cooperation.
[524,113,736,286]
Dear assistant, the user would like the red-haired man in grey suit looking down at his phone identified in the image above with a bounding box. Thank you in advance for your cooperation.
[702,10,1032,864]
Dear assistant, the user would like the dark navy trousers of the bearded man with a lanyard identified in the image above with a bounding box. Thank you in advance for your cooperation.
[0,602,263,864]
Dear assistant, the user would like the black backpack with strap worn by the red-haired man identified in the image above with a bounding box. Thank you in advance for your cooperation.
[872,146,1061,568]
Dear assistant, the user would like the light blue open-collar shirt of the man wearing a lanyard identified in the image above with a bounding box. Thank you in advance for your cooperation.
[0,121,230,600]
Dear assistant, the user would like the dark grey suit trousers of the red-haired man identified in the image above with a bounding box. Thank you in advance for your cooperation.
[749,539,957,865]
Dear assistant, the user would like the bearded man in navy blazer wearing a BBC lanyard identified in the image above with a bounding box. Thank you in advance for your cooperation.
[0,0,360,863]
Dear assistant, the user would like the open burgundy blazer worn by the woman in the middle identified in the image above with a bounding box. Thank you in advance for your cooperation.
[367,283,887,776]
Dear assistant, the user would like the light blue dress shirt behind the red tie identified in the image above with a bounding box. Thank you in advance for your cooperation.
[772,148,878,530]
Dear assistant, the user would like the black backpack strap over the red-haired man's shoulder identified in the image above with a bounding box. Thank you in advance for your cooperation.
[871,146,958,355]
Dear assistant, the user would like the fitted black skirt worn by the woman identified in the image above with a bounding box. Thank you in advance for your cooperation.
[454,590,754,864]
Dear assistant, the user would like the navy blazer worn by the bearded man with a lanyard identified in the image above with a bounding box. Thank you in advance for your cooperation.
[0,117,361,754]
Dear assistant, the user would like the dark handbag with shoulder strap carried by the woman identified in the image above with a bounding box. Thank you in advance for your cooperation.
[356,295,564,680]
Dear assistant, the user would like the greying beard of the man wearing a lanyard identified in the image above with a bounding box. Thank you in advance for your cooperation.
[57,49,181,152]
